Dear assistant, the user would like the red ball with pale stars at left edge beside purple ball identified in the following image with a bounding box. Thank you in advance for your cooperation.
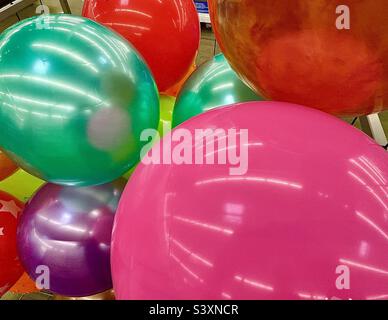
[0,191,23,297]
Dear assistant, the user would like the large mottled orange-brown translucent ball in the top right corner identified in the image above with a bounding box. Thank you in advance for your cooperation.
[209,0,388,116]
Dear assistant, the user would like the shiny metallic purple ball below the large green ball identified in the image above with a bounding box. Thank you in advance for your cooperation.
[17,179,125,297]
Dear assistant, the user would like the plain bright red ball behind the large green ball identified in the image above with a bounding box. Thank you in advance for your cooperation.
[82,0,200,92]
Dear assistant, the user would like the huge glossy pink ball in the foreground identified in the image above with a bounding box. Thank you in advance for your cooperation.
[112,102,388,300]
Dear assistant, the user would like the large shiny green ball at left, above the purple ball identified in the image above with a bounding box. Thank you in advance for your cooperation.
[0,15,159,186]
